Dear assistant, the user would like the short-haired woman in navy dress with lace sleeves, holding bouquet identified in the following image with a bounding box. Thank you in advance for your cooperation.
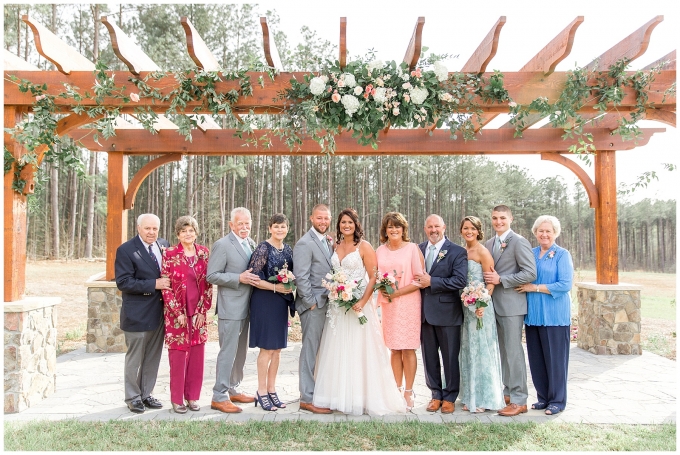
[248,213,294,411]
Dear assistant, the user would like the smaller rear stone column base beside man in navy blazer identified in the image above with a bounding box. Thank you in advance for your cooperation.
[85,272,127,352]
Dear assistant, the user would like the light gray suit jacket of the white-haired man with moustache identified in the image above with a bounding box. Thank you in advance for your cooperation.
[206,231,255,320]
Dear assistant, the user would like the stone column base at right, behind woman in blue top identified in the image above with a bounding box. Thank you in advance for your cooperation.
[575,282,642,355]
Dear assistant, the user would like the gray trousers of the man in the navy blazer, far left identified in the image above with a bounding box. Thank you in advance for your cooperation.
[123,321,165,403]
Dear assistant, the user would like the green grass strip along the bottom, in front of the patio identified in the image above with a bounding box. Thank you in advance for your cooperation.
[5,420,676,451]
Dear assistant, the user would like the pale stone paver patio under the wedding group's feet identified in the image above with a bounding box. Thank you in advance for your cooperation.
[5,342,677,424]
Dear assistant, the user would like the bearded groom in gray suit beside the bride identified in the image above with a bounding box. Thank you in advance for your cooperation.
[293,204,333,414]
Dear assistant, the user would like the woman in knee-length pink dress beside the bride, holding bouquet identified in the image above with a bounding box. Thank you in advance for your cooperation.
[376,212,425,409]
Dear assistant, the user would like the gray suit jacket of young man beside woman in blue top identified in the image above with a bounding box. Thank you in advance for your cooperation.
[485,230,536,316]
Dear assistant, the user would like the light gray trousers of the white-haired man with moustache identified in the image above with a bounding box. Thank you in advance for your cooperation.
[212,316,250,402]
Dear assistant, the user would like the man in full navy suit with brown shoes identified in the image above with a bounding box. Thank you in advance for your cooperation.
[415,215,467,414]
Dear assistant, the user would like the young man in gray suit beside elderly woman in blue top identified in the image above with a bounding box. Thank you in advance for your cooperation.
[484,205,536,417]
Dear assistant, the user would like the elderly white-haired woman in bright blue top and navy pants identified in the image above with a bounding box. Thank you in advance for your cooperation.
[516,215,574,415]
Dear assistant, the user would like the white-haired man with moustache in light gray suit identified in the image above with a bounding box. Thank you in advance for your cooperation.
[206,207,260,412]
